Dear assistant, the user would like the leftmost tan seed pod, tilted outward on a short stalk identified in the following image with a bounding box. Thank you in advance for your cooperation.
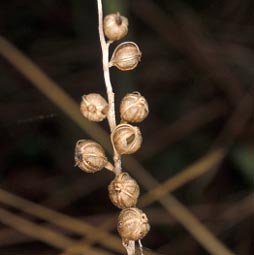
[75,139,113,173]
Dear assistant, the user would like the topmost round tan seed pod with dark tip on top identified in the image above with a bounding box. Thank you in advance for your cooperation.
[103,12,128,41]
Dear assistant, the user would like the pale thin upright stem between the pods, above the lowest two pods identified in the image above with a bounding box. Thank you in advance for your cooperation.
[97,0,122,175]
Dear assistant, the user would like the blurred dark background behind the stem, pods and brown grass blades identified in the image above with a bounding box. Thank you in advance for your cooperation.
[0,0,254,255]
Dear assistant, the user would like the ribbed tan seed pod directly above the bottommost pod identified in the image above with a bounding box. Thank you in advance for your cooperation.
[108,172,139,209]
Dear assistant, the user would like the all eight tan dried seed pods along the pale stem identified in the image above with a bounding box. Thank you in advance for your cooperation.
[75,10,150,246]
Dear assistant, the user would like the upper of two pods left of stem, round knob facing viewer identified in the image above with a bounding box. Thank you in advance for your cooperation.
[80,93,108,122]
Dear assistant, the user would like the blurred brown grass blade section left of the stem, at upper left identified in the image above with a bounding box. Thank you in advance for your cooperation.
[0,36,111,151]
